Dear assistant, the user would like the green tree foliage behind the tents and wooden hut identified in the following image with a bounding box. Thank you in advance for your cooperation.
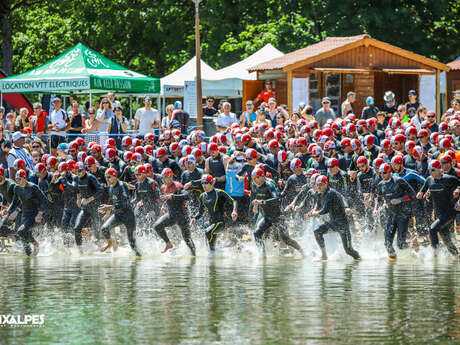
[0,0,460,77]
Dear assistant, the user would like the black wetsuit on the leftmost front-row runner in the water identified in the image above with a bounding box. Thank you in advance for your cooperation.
[8,182,48,255]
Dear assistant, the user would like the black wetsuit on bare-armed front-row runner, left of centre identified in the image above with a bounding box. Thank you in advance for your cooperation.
[153,181,195,255]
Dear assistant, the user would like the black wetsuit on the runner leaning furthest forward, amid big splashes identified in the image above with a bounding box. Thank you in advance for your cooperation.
[314,188,360,259]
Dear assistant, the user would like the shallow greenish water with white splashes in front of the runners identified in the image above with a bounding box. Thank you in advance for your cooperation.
[0,224,460,345]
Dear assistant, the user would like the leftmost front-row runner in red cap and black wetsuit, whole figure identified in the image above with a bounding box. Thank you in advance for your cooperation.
[7,169,48,256]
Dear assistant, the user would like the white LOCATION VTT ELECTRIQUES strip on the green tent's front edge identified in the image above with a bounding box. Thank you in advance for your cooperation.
[0,78,90,93]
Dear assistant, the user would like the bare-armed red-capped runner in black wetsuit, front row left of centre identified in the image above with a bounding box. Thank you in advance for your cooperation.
[153,168,196,256]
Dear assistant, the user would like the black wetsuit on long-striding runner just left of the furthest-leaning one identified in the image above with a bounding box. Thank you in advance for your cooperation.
[251,179,301,253]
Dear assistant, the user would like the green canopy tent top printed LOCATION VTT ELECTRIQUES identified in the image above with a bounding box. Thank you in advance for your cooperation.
[0,43,160,109]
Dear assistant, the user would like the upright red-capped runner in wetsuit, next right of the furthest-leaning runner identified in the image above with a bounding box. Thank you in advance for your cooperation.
[374,163,415,259]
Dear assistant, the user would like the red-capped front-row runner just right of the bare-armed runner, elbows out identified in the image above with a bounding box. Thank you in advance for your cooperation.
[190,174,238,253]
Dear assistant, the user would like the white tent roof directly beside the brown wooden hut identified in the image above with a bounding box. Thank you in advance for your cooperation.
[212,43,284,80]
